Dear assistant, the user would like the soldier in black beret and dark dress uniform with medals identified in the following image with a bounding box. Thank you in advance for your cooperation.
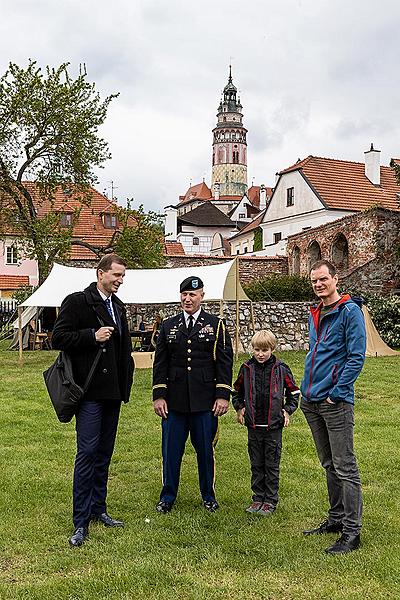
[153,277,233,513]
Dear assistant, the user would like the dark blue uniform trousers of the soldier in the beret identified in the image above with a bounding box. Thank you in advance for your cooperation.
[160,410,218,504]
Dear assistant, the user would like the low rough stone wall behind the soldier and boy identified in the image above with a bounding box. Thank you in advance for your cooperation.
[128,301,310,351]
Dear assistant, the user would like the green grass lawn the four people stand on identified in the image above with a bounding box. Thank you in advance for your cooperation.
[0,344,400,600]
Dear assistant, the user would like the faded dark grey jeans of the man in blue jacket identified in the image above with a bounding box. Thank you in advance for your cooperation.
[300,400,362,535]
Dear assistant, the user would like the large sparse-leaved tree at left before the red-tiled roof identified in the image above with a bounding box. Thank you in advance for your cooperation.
[0,61,116,282]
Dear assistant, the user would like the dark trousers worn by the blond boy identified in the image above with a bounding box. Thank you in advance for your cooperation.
[247,427,282,506]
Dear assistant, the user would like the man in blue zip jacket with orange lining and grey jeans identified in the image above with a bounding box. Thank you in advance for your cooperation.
[301,260,366,554]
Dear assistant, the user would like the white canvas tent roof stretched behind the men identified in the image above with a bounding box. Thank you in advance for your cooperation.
[21,260,249,306]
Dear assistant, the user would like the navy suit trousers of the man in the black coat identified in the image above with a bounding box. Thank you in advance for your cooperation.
[73,401,121,528]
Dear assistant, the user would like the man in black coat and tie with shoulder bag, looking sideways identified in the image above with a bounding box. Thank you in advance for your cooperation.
[52,254,134,546]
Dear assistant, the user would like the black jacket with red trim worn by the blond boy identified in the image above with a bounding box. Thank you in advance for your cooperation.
[232,356,300,429]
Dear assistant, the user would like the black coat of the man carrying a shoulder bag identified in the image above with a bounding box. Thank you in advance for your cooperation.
[52,283,134,402]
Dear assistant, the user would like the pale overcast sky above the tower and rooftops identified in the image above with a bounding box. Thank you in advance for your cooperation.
[0,0,400,211]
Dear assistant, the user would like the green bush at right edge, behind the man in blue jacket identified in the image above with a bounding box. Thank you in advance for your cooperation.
[364,294,400,348]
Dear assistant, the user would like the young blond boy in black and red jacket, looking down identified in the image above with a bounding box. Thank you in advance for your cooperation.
[232,330,300,515]
